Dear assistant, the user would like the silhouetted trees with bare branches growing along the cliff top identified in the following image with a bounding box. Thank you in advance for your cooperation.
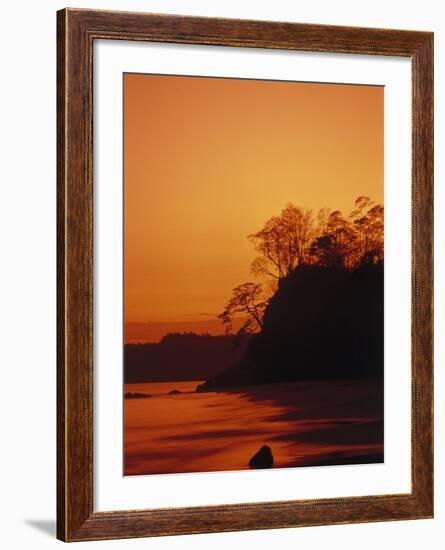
[219,196,384,334]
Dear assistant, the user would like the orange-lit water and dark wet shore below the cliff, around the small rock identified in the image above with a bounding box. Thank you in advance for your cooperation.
[124,381,383,475]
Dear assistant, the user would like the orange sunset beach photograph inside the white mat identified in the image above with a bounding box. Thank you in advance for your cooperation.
[123,73,385,476]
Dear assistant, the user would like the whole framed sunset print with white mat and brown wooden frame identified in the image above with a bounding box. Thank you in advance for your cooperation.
[57,9,433,541]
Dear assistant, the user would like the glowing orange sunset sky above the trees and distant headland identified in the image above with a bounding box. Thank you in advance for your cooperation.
[124,74,383,341]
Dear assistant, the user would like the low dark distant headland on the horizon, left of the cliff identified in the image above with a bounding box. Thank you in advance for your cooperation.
[124,333,250,383]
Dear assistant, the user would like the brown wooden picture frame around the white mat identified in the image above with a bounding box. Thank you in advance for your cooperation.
[57,9,433,541]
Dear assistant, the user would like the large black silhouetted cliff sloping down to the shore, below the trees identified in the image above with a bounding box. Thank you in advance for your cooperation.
[200,263,383,390]
